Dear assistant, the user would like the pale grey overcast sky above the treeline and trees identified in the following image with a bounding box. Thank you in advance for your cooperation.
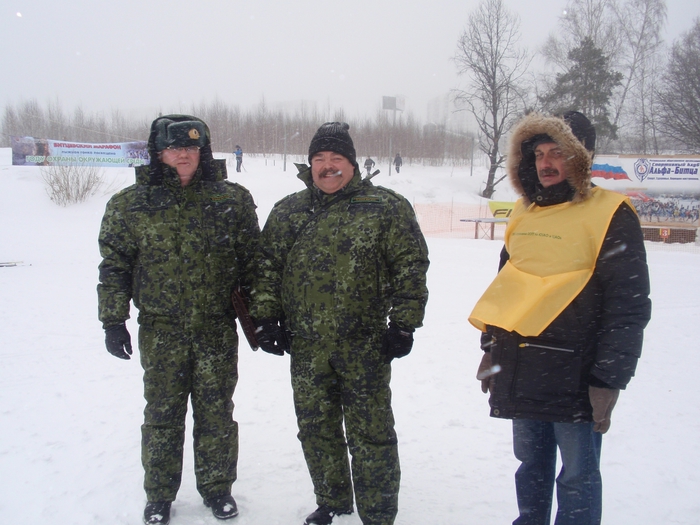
[0,0,700,120]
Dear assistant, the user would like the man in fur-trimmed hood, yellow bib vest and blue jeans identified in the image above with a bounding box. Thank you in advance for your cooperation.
[469,111,651,525]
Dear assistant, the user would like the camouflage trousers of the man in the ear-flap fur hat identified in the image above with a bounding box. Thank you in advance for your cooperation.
[139,323,238,501]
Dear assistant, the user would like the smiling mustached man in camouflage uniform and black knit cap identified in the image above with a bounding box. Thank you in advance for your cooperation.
[251,122,429,525]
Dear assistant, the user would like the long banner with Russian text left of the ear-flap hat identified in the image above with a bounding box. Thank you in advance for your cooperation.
[11,137,150,168]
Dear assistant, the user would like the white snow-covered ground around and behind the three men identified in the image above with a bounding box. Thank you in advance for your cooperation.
[0,149,700,525]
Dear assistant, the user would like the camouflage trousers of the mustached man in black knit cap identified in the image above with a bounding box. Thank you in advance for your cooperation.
[291,335,401,525]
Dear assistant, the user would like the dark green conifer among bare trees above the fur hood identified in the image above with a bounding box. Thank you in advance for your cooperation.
[540,38,622,139]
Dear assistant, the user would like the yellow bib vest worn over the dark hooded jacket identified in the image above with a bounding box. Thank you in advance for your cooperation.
[469,188,634,337]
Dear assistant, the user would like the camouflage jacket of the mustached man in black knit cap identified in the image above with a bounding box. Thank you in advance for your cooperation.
[251,165,429,339]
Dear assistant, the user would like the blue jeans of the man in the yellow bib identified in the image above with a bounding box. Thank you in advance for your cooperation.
[513,419,602,525]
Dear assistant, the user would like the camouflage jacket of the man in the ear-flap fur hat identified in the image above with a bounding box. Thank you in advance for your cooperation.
[97,161,260,327]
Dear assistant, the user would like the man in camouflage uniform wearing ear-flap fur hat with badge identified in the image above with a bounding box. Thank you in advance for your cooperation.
[97,115,260,524]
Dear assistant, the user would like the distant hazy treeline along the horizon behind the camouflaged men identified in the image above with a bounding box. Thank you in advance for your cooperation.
[0,100,478,165]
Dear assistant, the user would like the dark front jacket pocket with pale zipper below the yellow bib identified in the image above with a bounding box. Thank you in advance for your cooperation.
[513,341,581,404]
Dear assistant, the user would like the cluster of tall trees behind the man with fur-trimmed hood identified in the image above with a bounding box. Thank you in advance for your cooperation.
[454,0,700,198]
